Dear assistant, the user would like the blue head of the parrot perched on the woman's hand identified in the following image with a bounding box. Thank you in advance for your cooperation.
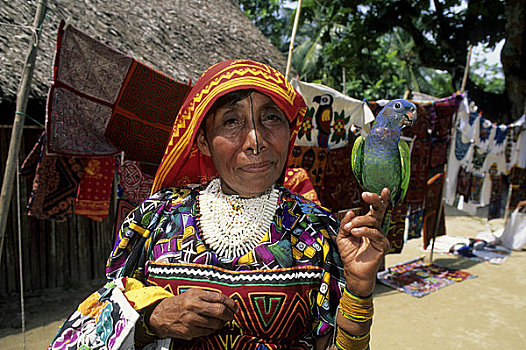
[376,99,416,130]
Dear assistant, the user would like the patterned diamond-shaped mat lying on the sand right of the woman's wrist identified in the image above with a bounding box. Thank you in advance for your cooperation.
[377,258,477,298]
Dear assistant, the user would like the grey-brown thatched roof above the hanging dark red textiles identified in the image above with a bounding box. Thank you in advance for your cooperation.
[0,0,286,102]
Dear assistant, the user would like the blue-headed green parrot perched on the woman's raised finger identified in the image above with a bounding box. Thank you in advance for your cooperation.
[352,100,416,233]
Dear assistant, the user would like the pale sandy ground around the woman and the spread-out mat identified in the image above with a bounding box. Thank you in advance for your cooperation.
[0,207,526,350]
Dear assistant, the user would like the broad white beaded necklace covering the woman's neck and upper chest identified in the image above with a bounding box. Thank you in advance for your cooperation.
[198,179,279,258]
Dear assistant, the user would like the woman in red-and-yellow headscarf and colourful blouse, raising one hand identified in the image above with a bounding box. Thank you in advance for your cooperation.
[51,60,389,349]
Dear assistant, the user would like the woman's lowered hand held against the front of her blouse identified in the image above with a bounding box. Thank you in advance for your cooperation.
[149,289,238,340]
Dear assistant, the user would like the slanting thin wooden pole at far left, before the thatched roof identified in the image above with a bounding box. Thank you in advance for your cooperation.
[0,0,47,261]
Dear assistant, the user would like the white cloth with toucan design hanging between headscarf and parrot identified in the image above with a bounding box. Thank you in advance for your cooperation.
[292,79,374,149]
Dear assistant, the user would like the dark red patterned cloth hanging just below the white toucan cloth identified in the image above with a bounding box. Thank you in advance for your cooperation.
[288,146,327,197]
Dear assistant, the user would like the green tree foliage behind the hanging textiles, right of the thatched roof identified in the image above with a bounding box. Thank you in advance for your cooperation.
[235,0,505,99]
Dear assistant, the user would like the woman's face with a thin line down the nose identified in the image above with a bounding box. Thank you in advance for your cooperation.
[197,92,290,198]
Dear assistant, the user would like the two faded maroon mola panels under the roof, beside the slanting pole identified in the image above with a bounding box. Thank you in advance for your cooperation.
[46,22,132,156]
